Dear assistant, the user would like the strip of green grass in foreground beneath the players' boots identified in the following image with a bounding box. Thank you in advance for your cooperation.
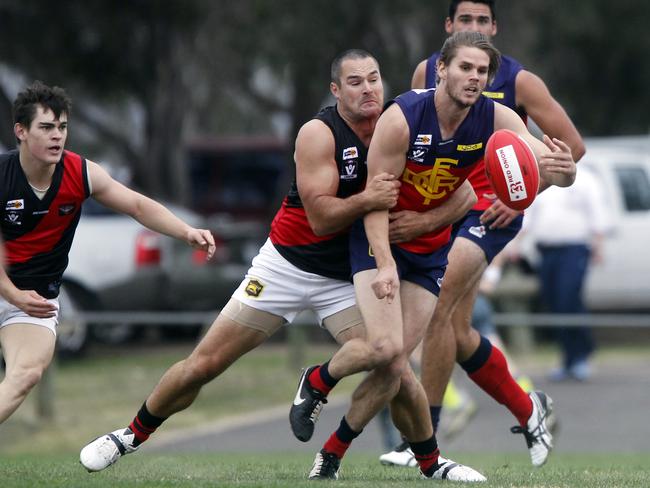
[0,453,650,488]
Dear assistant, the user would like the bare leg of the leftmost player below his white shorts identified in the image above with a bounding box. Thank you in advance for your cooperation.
[0,324,56,424]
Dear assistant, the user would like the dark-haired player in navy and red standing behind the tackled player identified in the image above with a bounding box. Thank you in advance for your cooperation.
[380,0,585,465]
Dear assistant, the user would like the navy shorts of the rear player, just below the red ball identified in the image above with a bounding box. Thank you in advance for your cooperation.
[451,210,524,264]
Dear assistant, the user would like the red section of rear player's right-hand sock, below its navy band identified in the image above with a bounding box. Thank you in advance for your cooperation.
[469,346,533,426]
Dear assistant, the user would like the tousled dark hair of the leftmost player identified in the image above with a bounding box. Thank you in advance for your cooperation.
[13,80,72,127]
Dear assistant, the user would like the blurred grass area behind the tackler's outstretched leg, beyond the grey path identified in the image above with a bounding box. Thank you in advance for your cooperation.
[0,345,358,454]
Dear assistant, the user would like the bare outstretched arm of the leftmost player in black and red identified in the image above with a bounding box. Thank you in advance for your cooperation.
[88,161,215,258]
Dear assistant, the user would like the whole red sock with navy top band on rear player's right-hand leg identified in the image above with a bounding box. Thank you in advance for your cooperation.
[460,336,533,426]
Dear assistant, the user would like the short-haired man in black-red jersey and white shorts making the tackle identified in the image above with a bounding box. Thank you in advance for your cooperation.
[80,49,473,476]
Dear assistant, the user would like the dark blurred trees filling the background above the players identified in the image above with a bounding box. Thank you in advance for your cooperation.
[0,0,650,203]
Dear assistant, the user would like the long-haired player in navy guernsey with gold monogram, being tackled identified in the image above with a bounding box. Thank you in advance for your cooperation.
[294,32,575,482]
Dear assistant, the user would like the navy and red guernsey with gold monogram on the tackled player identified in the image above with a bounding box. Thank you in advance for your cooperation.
[391,89,494,253]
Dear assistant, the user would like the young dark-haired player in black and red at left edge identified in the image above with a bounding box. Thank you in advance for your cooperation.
[0,82,214,423]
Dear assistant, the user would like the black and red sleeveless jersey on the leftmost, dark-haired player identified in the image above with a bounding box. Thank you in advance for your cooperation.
[0,151,90,298]
